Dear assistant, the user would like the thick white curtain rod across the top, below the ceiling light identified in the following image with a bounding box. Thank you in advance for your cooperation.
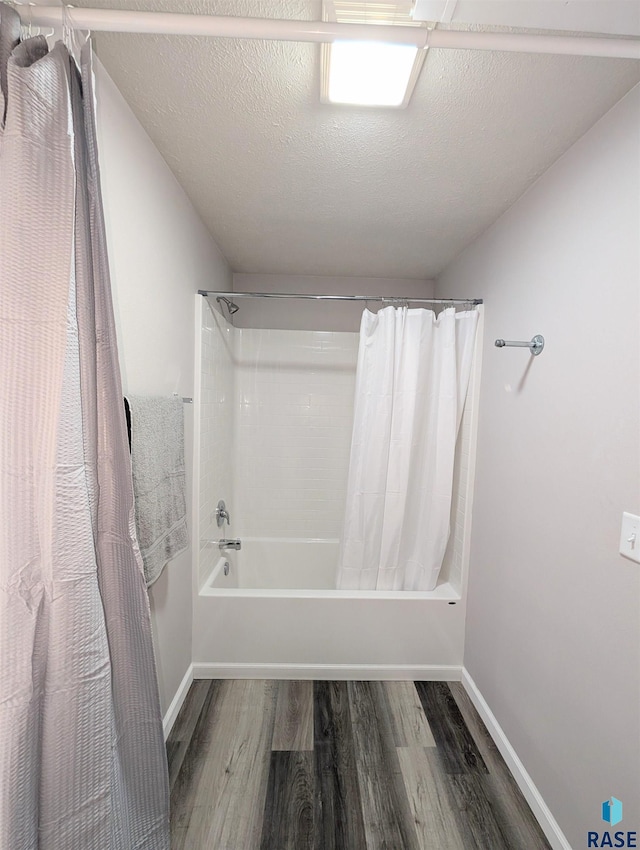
[16,3,640,59]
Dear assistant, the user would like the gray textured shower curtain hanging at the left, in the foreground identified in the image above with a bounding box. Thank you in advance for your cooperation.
[0,4,169,850]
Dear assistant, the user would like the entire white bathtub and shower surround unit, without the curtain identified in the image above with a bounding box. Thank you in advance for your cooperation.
[193,295,480,679]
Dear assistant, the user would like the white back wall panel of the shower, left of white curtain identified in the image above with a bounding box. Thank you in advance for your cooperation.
[235,328,358,539]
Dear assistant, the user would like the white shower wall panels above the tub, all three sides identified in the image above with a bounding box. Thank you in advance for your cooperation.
[198,302,481,592]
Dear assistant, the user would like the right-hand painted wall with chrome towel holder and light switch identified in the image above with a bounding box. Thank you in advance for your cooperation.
[438,87,640,848]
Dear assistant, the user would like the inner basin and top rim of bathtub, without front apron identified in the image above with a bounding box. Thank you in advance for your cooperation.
[200,537,460,601]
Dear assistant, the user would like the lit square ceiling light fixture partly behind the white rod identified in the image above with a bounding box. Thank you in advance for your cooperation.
[320,0,426,109]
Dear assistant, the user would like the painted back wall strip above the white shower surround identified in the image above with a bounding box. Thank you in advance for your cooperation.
[233,273,434,332]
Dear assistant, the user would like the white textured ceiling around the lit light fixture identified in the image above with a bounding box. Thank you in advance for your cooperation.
[78,0,640,278]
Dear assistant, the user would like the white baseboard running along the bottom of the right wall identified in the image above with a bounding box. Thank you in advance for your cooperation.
[461,667,571,850]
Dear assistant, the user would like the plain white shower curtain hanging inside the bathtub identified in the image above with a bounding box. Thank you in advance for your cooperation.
[338,307,478,590]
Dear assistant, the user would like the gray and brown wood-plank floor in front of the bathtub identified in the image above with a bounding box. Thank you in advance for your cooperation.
[167,680,550,850]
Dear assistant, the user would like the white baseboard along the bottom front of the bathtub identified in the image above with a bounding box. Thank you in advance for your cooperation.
[192,661,462,682]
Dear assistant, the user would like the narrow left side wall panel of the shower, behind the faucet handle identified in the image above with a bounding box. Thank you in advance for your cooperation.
[198,301,237,585]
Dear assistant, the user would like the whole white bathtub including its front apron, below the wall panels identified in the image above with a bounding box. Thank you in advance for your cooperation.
[193,535,465,680]
